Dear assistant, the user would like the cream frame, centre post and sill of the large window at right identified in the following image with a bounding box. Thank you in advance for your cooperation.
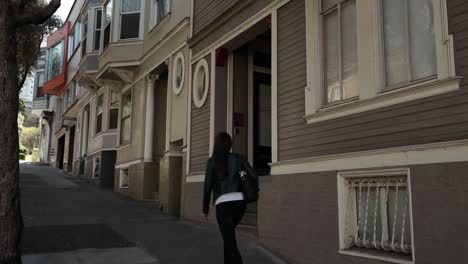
[305,0,461,124]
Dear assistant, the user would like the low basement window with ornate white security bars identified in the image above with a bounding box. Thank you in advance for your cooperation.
[340,174,413,255]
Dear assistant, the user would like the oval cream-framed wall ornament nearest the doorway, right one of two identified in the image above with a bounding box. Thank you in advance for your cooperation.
[193,59,210,108]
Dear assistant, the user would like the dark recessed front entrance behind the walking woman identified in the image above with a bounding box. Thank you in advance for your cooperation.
[227,26,272,228]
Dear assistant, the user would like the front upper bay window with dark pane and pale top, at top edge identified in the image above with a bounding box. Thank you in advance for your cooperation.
[120,0,141,39]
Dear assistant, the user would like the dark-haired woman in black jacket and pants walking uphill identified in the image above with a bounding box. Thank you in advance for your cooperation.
[203,132,258,264]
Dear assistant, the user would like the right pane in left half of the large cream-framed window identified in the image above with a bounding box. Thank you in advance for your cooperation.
[341,0,359,99]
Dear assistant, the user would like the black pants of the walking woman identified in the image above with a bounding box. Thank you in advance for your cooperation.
[216,201,245,264]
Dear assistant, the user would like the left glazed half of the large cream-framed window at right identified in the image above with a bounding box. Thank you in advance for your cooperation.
[321,0,359,103]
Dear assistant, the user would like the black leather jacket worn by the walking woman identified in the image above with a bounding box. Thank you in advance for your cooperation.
[203,153,258,214]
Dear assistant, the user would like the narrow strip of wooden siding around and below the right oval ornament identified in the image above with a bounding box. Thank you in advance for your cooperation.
[190,56,211,173]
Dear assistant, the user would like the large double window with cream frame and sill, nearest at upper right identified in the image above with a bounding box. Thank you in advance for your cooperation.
[305,0,461,124]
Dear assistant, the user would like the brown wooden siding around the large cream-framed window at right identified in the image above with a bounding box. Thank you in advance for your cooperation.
[278,0,468,160]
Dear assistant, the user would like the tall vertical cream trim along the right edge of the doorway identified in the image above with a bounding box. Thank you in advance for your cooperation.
[271,10,278,162]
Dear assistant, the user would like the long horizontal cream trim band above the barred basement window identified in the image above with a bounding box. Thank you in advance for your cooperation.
[271,140,468,175]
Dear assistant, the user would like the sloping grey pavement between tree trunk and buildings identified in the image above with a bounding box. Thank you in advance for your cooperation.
[20,164,282,264]
